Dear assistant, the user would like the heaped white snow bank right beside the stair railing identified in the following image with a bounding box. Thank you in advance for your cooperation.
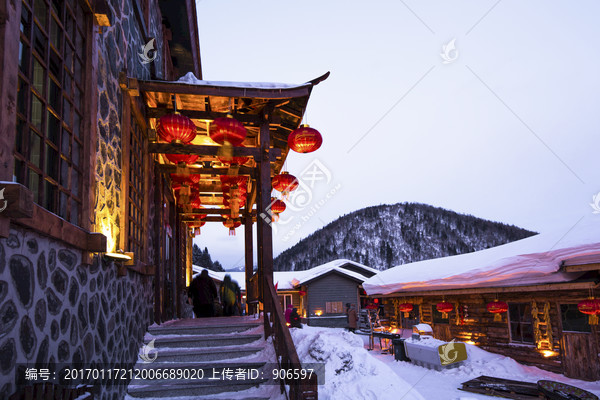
[290,326,424,400]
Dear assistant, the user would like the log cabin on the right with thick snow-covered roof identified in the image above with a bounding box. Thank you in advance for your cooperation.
[364,221,600,380]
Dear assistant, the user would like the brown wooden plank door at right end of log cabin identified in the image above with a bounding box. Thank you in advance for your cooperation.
[561,332,600,381]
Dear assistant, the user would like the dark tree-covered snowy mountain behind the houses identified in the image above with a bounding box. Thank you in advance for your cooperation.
[274,203,535,271]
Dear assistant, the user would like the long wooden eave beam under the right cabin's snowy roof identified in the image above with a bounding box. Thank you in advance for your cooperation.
[370,281,600,297]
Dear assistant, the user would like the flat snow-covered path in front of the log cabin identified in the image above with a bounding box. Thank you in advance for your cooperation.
[363,336,600,400]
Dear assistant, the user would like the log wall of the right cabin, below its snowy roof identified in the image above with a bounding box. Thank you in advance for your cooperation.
[383,289,600,380]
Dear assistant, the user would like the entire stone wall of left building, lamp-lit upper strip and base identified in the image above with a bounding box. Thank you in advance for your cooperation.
[0,0,169,400]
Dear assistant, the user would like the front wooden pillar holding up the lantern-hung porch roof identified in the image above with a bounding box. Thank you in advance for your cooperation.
[256,104,273,315]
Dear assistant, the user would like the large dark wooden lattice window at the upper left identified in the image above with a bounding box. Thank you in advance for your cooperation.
[13,0,89,225]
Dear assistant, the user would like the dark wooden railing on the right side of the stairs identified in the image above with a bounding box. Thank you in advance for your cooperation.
[264,276,318,400]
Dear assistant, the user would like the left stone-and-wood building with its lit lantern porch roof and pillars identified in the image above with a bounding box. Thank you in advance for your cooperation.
[0,0,327,399]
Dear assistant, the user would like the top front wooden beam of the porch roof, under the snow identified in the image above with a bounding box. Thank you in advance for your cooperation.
[139,81,312,99]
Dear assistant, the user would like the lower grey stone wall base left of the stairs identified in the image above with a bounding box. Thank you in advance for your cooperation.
[0,229,153,399]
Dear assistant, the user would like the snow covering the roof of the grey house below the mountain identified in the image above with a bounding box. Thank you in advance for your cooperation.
[192,259,378,290]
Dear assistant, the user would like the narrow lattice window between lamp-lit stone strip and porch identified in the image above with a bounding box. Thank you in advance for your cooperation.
[126,115,147,259]
